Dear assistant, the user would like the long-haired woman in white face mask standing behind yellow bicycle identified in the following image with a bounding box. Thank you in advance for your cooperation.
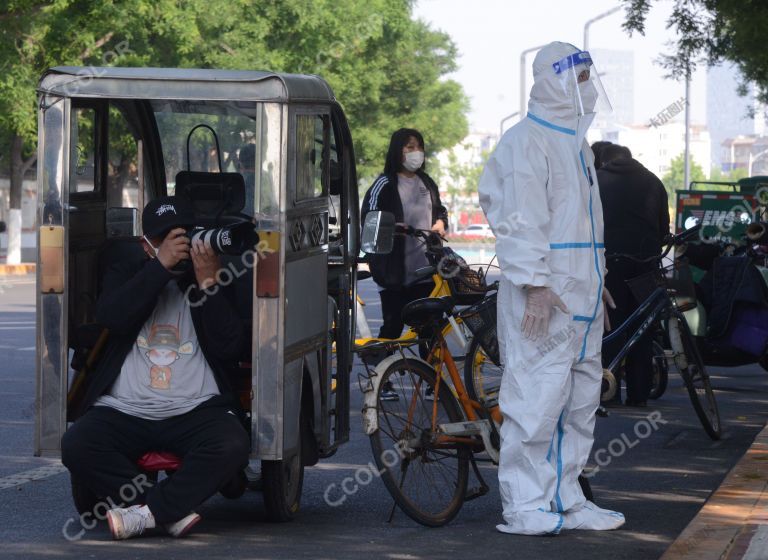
[362,128,448,400]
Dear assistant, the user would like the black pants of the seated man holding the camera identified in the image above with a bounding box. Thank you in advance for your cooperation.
[61,406,250,524]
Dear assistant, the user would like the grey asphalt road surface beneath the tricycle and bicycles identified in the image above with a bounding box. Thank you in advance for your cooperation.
[0,277,768,560]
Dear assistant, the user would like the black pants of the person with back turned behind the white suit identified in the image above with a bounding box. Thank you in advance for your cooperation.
[603,259,655,402]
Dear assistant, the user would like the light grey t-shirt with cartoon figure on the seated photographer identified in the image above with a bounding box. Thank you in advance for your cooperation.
[95,281,219,420]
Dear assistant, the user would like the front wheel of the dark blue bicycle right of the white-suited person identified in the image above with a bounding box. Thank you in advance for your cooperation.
[669,311,722,440]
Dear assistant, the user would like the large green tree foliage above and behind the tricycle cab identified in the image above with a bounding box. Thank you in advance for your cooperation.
[0,0,468,184]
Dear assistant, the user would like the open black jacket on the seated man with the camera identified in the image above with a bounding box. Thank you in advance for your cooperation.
[71,254,246,420]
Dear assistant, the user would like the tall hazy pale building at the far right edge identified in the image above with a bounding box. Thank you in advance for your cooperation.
[707,64,768,172]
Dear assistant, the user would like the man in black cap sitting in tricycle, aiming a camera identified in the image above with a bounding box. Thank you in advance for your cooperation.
[61,197,250,539]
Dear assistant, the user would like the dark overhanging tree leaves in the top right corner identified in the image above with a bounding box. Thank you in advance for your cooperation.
[624,0,768,103]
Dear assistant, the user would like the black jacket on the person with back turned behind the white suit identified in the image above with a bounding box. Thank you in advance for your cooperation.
[597,158,669,257]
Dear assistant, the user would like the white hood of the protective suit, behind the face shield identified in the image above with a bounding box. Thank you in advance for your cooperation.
[528,41,593,135]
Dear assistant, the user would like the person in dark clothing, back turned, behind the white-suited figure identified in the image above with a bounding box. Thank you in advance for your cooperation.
[597,144,669,406]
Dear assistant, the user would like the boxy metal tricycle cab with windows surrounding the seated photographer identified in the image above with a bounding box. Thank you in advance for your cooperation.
[35,67,359,516]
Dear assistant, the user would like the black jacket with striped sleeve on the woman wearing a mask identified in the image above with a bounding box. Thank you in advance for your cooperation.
[361,171,448,288]
